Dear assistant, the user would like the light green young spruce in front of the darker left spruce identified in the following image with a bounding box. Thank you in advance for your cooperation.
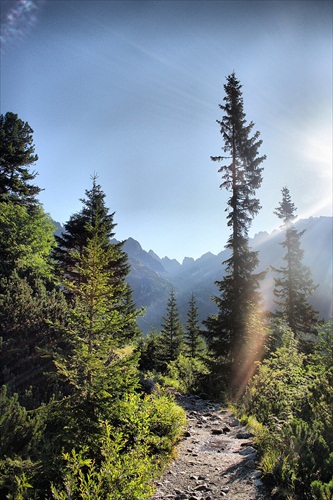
[54,219,138,444]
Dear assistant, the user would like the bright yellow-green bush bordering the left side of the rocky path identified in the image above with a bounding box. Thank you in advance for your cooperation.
[52,394,185,500]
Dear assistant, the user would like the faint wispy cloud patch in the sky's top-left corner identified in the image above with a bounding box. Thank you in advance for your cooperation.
[0,0,45,51]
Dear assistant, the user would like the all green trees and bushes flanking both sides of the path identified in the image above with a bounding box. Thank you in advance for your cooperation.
[0,73,333,500]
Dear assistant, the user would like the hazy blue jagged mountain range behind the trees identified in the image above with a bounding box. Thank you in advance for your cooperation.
[56,217,333,332]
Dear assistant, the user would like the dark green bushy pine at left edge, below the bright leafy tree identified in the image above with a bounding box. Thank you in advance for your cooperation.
[0,271,67,407]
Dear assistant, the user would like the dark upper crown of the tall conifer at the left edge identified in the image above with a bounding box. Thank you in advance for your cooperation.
[0,112,41,210]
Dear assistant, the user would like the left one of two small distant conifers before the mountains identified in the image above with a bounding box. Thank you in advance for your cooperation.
[160,290,184,363]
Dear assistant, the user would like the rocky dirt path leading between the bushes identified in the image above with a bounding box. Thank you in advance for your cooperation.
[151,396,270,500]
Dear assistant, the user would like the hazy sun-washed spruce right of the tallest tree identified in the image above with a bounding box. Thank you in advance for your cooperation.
[273,187,318,336]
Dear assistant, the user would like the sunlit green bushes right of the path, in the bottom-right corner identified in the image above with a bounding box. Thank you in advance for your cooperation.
[242,323,333,499]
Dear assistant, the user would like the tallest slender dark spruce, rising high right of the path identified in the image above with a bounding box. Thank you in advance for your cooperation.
[204,73,266,383]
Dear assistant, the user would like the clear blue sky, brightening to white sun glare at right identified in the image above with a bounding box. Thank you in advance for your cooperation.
[0,0,332,261]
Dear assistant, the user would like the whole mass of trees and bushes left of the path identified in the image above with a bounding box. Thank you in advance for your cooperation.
[0,118,185,500]
